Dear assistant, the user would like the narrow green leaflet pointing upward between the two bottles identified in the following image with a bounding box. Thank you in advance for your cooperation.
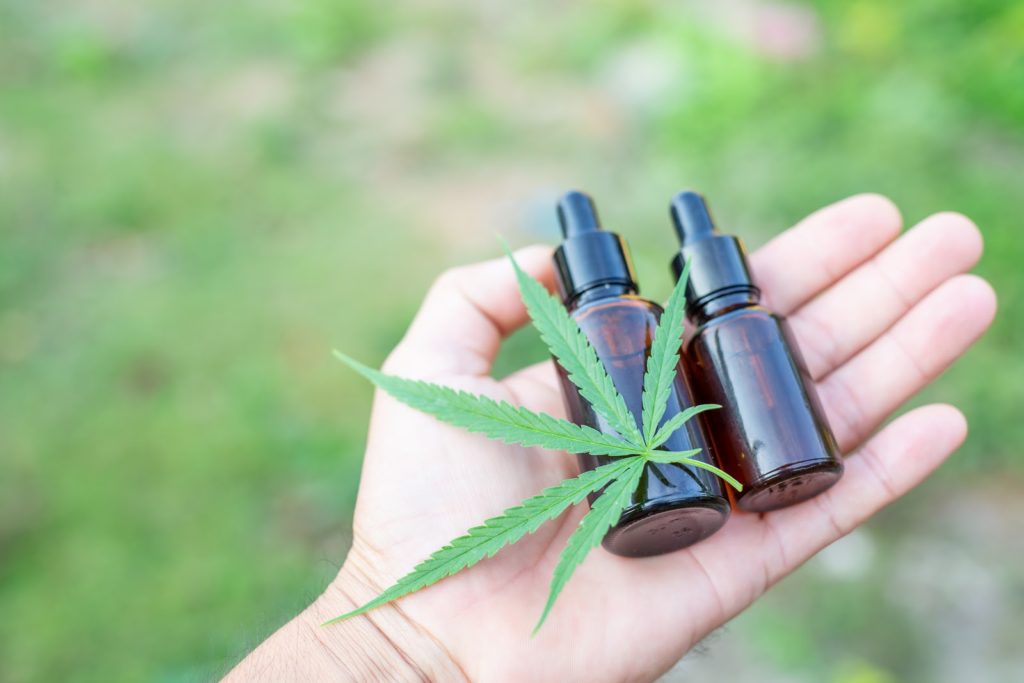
[642,259,690,443]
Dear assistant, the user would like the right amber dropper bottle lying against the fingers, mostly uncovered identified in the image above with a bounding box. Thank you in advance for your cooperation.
[671,191,843,512]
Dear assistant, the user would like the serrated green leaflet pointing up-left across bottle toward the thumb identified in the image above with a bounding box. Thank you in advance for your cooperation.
[509,248,644,447]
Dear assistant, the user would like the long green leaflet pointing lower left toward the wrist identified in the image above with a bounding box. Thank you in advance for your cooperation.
[325,458,642,626]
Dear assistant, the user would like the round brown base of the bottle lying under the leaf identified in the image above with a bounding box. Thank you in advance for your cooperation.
[602,498,729,557]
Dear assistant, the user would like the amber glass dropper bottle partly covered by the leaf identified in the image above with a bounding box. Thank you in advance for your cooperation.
[555,191,729,557]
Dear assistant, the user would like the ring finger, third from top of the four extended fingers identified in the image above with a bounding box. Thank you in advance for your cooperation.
[818,275,995,453]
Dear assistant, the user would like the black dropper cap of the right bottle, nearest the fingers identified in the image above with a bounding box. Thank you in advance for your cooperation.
[670,190,761,313]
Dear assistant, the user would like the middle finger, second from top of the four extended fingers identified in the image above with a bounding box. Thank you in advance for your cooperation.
[790,213,982,379]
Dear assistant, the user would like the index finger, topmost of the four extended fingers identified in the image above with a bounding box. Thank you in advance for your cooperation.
[751,195,902,315]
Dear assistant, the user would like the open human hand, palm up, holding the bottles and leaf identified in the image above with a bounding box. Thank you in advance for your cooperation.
[228,195,995,681]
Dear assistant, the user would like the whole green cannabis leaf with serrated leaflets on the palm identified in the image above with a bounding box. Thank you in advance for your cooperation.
[327,254,741,633]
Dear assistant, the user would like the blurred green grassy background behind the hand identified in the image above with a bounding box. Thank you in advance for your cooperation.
[0,0,1024,681]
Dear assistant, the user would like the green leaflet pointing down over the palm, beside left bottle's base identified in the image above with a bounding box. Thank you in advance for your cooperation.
[534,458,646,634]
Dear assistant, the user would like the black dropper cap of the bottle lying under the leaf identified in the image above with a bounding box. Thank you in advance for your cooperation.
[555,190,637,303]
